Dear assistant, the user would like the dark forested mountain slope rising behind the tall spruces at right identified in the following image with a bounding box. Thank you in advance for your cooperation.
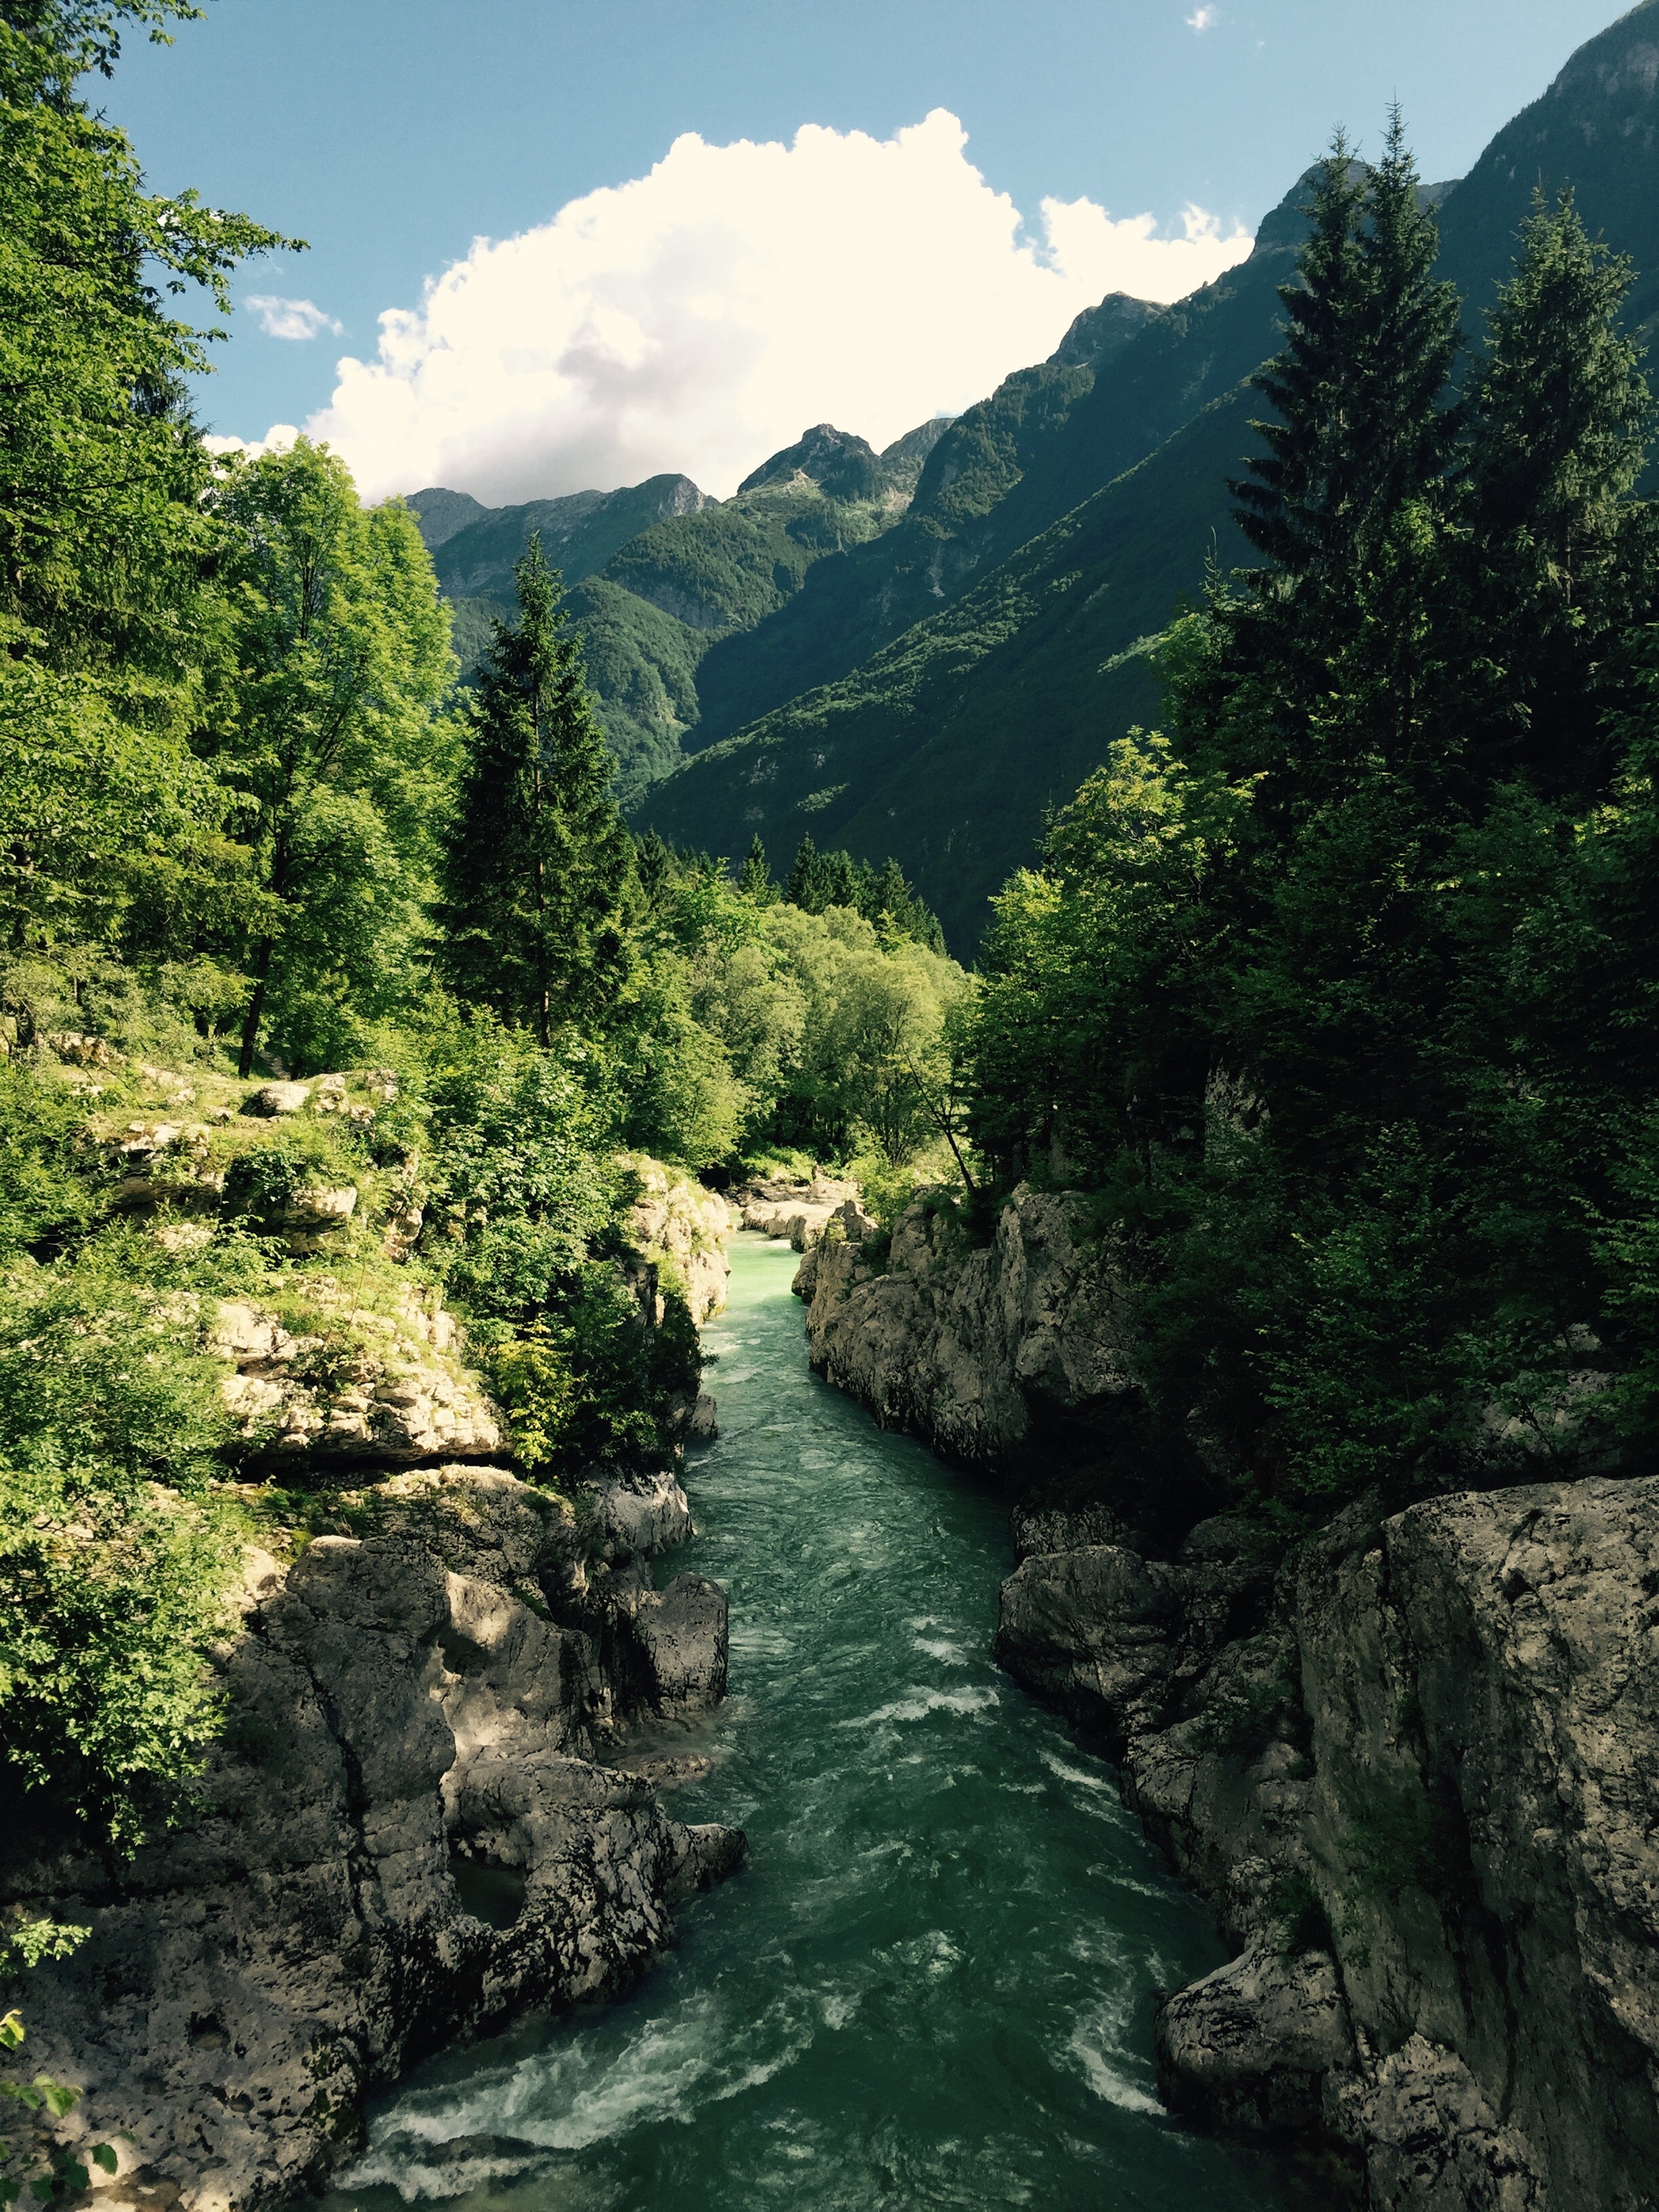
[637,0,1659,949]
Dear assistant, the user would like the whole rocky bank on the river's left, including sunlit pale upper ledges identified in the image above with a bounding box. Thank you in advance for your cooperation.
[0,1133,743,2212]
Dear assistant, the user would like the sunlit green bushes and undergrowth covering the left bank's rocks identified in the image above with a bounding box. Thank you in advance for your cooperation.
[0,1004,699,1885]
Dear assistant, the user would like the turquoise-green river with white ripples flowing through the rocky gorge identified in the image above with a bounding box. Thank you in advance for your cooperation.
[327,1237,1298,2212]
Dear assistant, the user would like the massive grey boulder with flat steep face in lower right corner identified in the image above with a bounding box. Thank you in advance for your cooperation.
[1057,1478,1659,2212]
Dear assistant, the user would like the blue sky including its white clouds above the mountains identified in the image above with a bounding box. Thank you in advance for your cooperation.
[100,0,1619,504]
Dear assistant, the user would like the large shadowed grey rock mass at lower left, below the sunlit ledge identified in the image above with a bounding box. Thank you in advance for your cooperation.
[0,1467,743,2212]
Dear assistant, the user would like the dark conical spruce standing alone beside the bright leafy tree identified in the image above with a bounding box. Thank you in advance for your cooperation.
[445,535,639,1044]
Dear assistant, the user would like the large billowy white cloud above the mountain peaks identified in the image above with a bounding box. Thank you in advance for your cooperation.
[285,108,1250,502]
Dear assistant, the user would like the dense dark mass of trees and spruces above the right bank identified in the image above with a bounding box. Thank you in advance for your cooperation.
[964,133,1659,1515]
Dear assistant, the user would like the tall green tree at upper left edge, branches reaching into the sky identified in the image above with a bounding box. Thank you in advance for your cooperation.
[0,0,290,681]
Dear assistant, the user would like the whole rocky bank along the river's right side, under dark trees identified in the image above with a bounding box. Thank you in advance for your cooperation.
[796,1190,1659,2212]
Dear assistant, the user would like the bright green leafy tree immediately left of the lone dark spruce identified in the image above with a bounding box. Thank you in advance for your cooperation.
[210,438,456,1075]
